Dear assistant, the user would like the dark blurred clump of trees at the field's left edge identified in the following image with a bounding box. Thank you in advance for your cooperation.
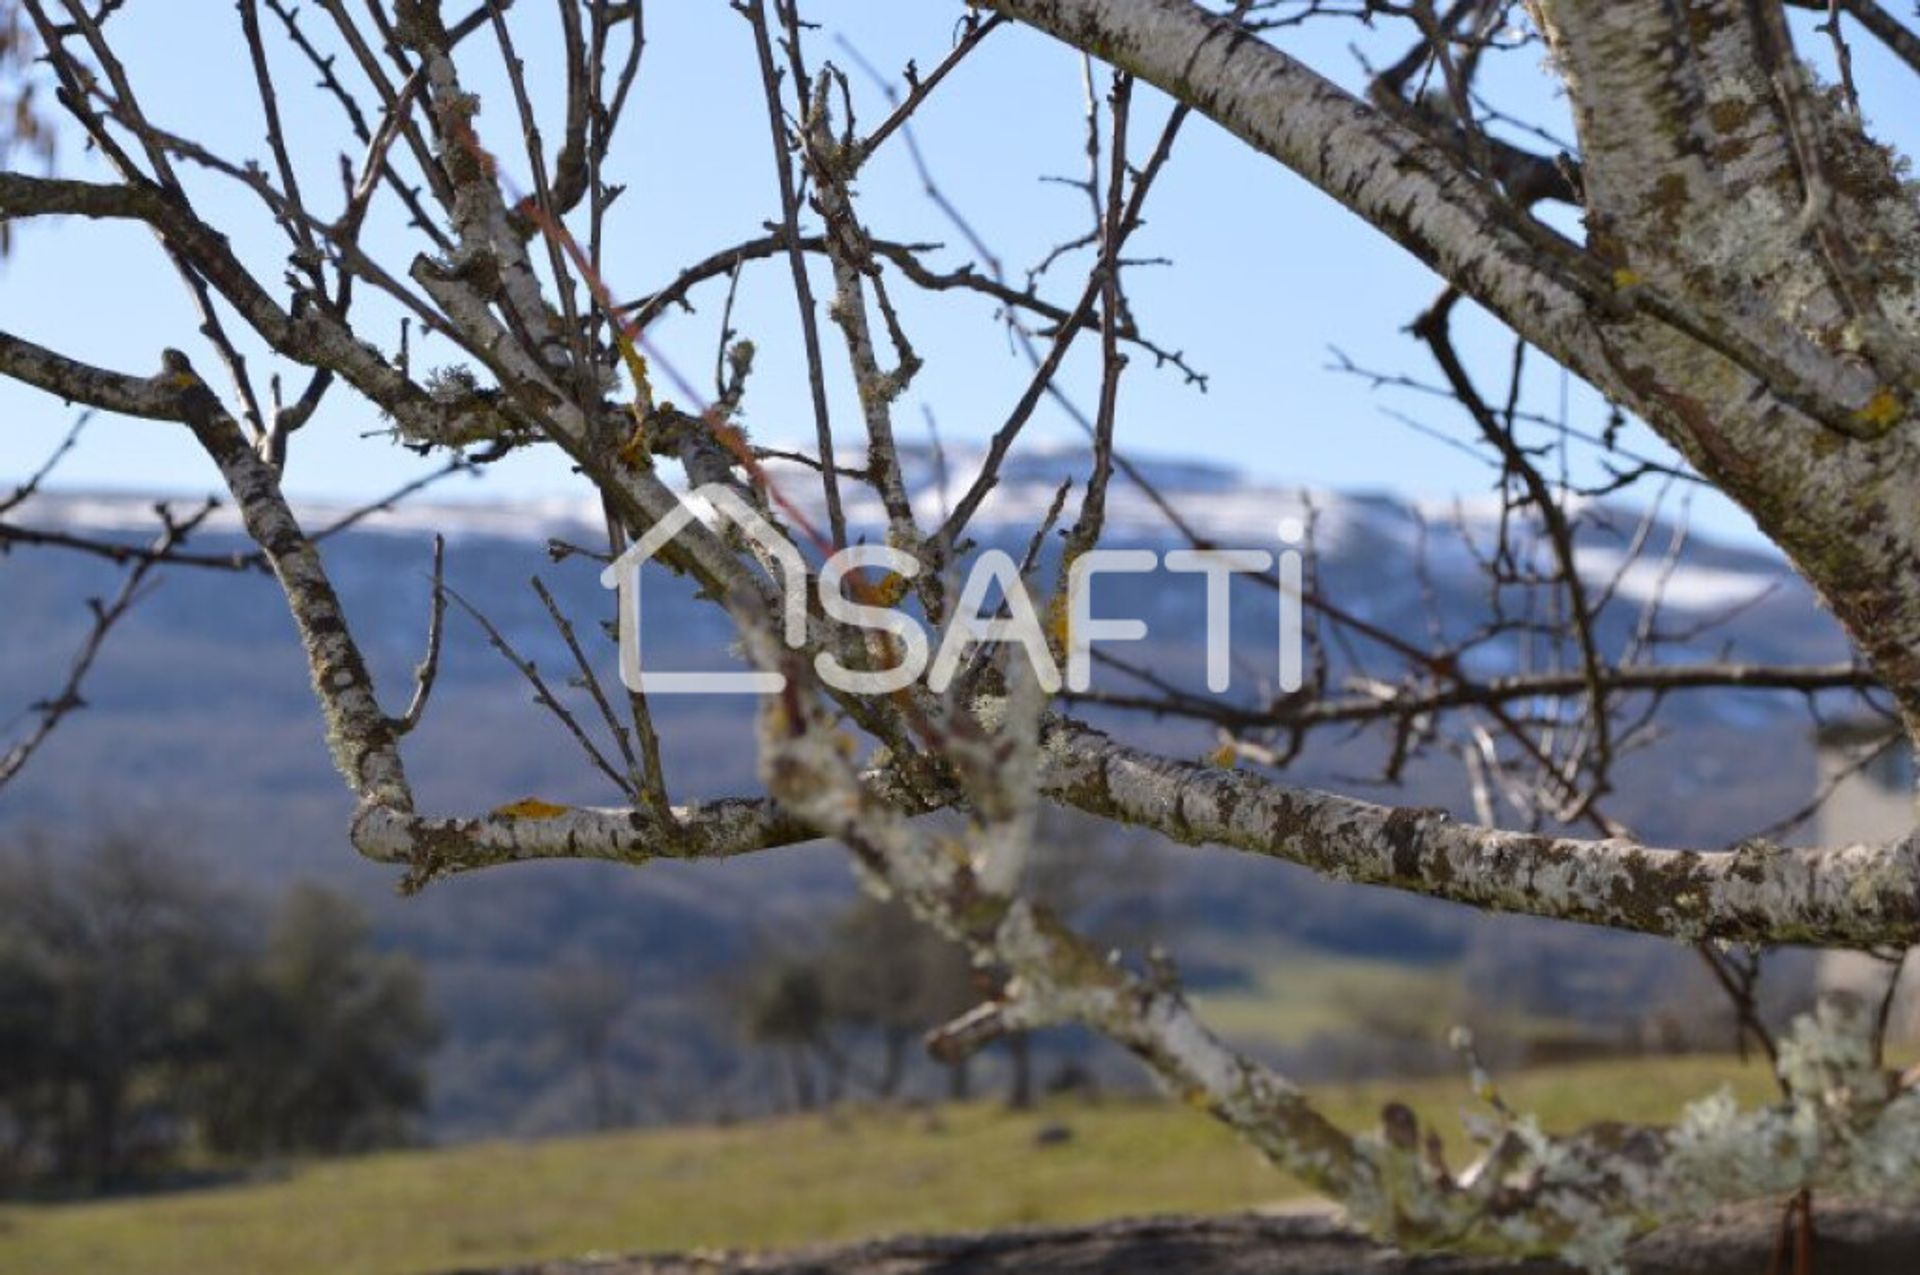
[0,833,436,1187]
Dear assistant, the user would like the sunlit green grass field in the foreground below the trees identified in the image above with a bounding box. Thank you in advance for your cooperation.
[0,1058,1770,1275]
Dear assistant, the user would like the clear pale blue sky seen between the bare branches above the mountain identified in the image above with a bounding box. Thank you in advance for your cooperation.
[0,0,1916,538]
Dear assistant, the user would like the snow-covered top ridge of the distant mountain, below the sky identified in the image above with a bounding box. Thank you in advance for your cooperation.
[15,447,1791,611]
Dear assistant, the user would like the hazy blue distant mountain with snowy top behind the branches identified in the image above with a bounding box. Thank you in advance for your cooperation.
[0,451,1845,1137]
